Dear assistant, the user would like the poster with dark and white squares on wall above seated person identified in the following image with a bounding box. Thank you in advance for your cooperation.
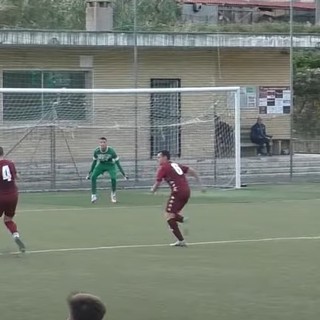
[259,87,291,114]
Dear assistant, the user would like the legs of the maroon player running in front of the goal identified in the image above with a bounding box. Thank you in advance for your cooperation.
[165,195,186,247]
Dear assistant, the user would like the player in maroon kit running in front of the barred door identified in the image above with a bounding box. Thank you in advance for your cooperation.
[151,150,204,247]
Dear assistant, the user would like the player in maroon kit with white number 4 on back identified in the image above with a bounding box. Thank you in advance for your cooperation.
[0,147,26,252]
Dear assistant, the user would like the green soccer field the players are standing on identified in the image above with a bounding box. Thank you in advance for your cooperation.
[0,184,320,320]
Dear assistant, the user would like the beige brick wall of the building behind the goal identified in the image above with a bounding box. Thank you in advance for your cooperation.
[0,49,289,162]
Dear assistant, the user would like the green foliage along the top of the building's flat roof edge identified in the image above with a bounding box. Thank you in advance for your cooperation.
[0,0,320,34]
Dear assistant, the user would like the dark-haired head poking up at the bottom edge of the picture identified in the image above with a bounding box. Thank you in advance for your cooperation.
[67,293,106,320]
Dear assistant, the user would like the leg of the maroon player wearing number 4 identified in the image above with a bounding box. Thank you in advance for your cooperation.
[3,195,26,252]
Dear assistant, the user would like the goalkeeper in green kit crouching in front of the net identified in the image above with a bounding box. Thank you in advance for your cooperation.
[87,137,128,203]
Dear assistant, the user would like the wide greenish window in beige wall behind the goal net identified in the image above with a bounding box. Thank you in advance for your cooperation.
[3,71,90,121]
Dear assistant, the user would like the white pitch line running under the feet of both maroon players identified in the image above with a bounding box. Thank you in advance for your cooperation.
[0,236,320,256]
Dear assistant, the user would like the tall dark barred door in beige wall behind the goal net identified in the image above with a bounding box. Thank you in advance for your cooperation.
[150,79,181,158]
